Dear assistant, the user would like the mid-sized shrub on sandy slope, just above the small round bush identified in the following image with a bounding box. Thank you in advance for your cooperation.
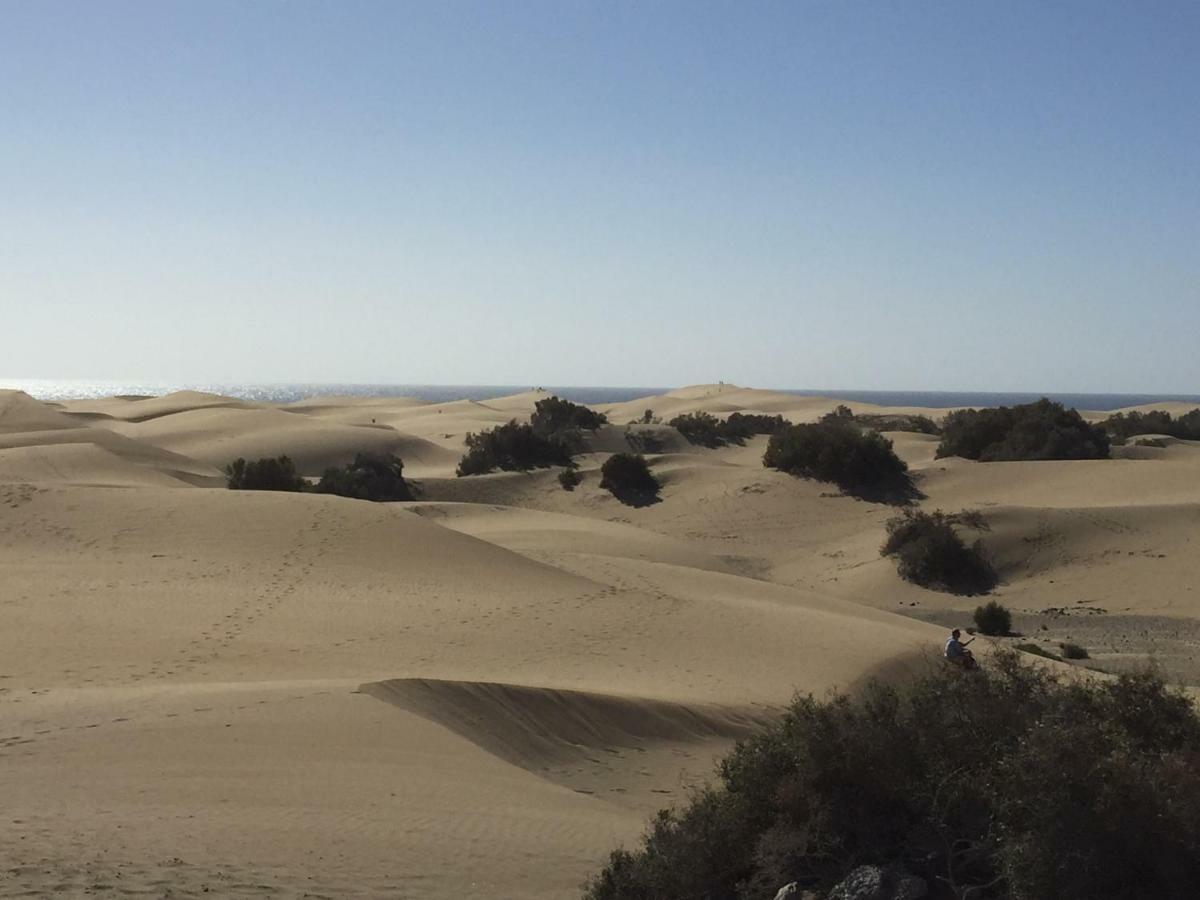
[881,510,996,594]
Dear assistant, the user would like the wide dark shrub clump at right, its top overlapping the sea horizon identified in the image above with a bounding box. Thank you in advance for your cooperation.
[937,397,1109,462]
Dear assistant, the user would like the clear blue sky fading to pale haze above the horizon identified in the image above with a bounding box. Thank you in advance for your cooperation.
[0,0,1200,394]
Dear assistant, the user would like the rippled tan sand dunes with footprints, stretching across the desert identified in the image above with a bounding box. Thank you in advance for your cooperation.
[0,385,1200,898]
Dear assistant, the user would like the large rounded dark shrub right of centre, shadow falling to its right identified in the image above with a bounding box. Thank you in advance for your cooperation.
[762,424,914,499]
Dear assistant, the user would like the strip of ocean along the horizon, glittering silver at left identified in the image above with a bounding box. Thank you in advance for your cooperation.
[0,378,1200,410]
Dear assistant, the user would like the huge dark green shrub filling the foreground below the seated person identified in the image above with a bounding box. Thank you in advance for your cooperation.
[587,652,1200,900]
